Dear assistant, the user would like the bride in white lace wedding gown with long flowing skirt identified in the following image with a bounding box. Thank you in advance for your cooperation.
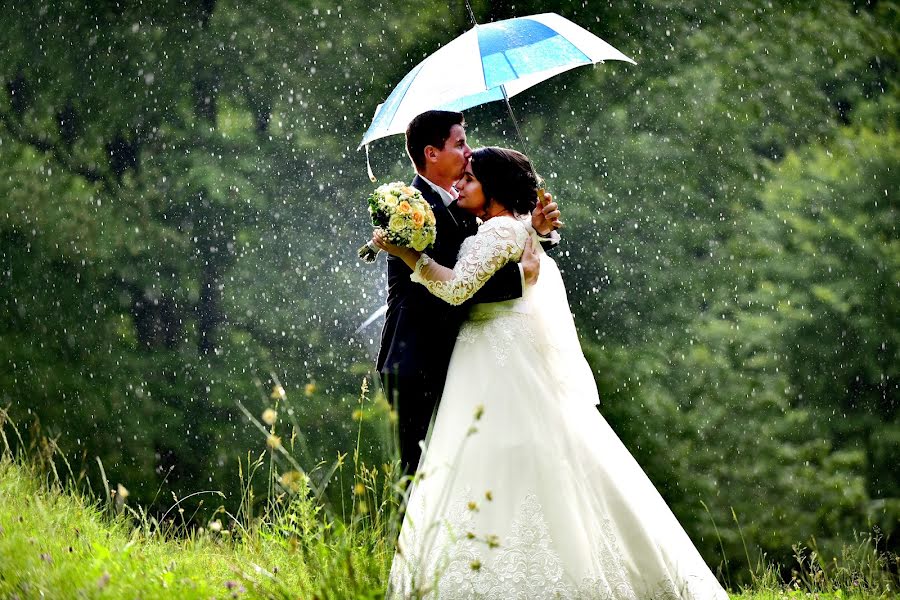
[375,148,728,600]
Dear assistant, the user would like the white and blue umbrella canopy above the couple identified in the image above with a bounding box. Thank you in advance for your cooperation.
[359,13,635,148]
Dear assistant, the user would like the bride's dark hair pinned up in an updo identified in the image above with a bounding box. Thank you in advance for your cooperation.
[472,146,538,215]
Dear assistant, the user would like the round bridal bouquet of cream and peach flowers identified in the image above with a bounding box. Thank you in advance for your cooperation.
[358,181,437,263]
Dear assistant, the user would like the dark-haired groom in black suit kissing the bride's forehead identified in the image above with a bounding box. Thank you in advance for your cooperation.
[376,110,559,474]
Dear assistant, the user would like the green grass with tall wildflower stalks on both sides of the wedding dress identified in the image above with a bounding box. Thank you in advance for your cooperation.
[0,384,900,600]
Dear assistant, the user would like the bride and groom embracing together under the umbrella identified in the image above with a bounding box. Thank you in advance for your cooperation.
[373,111,728,600]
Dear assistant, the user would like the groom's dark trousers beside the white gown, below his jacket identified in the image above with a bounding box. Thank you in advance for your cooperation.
[381,373,444,475]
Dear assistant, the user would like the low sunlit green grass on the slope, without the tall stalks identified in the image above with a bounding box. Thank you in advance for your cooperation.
[0,455,897,600]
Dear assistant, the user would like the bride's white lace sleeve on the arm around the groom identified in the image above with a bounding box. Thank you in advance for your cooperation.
[410,217,528,305]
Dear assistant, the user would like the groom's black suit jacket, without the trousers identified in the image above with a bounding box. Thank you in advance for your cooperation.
[376,175,522,381]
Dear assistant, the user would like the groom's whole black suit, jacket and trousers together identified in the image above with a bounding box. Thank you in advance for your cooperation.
[377,175,522,473]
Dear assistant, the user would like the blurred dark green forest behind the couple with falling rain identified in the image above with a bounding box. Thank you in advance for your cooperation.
[0,0,900,574]
